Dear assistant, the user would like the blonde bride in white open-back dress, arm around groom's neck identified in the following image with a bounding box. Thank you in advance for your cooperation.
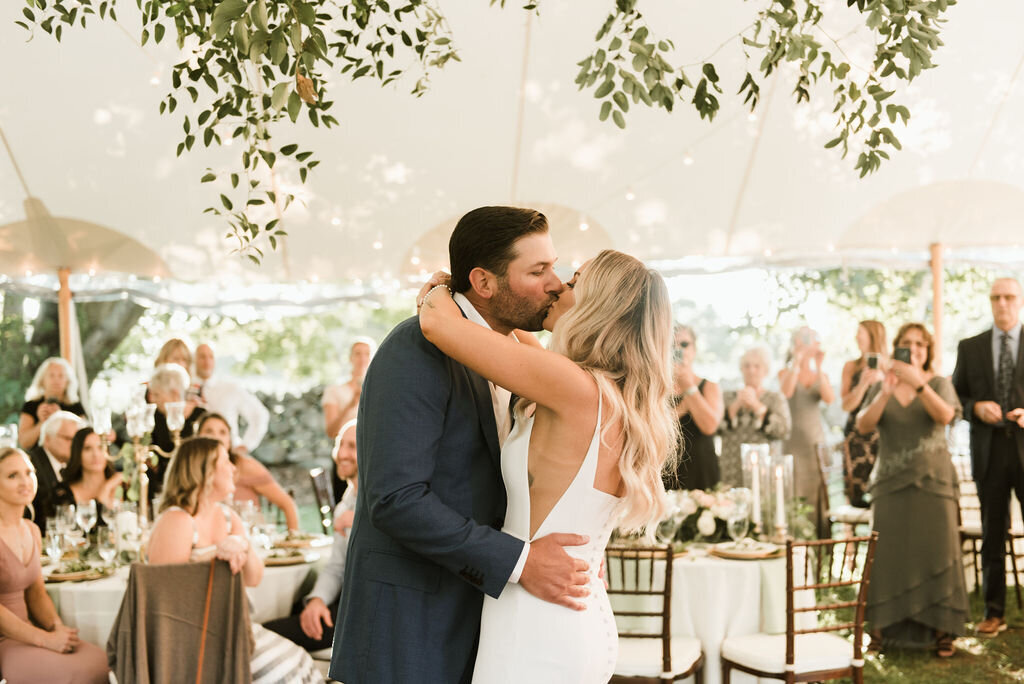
[420,250,676,684]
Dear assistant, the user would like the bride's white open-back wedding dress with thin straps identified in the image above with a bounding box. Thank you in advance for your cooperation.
[473,395,621,684]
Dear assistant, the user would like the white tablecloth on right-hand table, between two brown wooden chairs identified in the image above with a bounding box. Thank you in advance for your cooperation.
[612,554,785,684]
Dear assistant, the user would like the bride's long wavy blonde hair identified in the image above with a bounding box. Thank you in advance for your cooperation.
[551,250,679,533]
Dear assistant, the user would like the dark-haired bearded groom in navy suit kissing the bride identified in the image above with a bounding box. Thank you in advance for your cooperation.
[331,207,588,684]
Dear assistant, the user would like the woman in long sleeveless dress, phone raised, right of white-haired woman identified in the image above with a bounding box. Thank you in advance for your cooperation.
[778,326,836,539]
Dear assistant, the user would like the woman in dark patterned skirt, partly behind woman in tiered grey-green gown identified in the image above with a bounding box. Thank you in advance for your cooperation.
[840,320,889,508]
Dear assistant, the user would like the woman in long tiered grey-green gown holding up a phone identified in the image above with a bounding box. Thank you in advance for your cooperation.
[857,323,968,657]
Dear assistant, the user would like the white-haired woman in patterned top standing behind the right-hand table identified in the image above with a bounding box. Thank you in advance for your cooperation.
[719,346,792,486]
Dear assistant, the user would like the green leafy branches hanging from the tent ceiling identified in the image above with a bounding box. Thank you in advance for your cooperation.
[16,0,955,263]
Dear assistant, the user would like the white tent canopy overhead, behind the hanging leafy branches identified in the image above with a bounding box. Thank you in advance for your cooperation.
[0,0,1024,305]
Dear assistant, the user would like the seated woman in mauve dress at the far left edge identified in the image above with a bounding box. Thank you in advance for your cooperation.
[0,446,108,684]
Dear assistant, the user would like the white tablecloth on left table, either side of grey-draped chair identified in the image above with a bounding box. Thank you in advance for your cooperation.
[46,547,331,649]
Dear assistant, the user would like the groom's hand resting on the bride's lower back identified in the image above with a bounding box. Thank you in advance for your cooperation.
[519,533,590,610]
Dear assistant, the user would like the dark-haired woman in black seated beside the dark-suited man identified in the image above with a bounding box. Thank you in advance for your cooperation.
[55,427,124,525]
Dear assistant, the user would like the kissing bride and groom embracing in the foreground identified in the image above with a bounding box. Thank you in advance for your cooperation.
[330,207,677,684]
